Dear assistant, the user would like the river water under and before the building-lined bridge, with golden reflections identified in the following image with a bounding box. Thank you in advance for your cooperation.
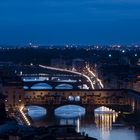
[27,106,140,140]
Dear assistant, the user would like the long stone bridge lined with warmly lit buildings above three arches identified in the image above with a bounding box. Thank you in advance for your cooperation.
[25,89,140,113]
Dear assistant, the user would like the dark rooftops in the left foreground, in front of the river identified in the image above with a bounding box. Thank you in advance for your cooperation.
[0,121,97,140]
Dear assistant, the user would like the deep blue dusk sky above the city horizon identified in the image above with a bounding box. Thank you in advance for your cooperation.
[0,0,140,45]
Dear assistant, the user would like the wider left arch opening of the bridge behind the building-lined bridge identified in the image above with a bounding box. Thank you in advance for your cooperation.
[31,83,53,89]
